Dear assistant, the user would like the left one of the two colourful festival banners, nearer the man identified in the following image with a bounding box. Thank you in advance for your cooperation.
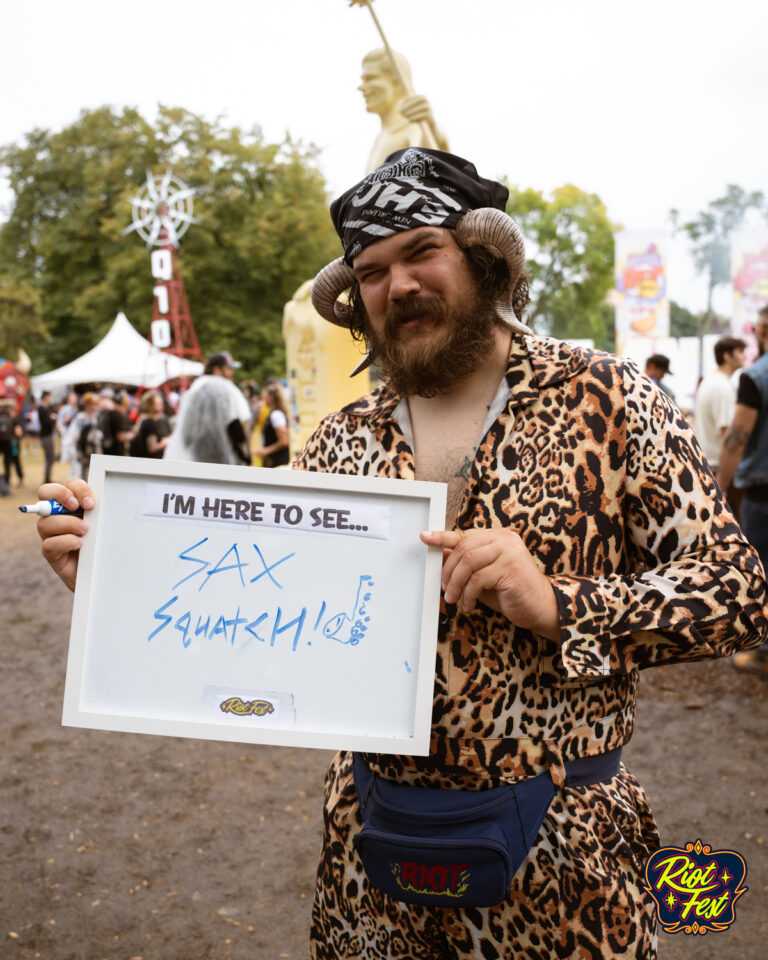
[614,230,669,356]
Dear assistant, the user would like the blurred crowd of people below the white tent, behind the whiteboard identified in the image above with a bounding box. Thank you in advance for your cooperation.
[0,352,290,494]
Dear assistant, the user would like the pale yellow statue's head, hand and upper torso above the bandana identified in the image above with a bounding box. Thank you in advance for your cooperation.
[359,49,449,173]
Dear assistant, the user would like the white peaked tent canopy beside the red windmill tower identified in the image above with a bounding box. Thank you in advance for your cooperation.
[30,311,204,397]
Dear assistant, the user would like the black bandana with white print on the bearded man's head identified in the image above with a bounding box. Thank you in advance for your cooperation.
[331,147,509,266]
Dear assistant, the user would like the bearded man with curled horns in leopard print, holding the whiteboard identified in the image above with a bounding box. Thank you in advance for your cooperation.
[33,149,768,960]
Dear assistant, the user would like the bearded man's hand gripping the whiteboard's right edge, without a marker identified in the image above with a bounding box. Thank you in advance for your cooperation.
[421,527,560,640]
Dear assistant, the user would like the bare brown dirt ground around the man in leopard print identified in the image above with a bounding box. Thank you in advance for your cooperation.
[0,454,768,960]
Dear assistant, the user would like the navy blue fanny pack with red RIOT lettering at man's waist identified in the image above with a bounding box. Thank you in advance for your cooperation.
[354,748,621,907]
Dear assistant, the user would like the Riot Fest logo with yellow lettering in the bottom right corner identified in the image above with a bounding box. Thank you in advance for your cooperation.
[645,840,748,935]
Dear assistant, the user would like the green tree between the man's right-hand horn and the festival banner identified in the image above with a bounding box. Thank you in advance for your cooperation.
[507,184,616,349]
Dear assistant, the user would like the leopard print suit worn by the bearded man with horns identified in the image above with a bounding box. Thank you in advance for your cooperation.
[295,338,768,960]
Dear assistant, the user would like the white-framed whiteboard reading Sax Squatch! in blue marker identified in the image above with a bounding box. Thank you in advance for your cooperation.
[62,456,445,755]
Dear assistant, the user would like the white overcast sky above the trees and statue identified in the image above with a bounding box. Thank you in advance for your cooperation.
[0,0,768,309]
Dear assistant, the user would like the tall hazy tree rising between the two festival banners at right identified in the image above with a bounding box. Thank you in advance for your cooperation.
[669,183,763,336]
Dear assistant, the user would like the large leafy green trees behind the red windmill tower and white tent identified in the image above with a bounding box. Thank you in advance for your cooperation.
[0,106,340,378]
